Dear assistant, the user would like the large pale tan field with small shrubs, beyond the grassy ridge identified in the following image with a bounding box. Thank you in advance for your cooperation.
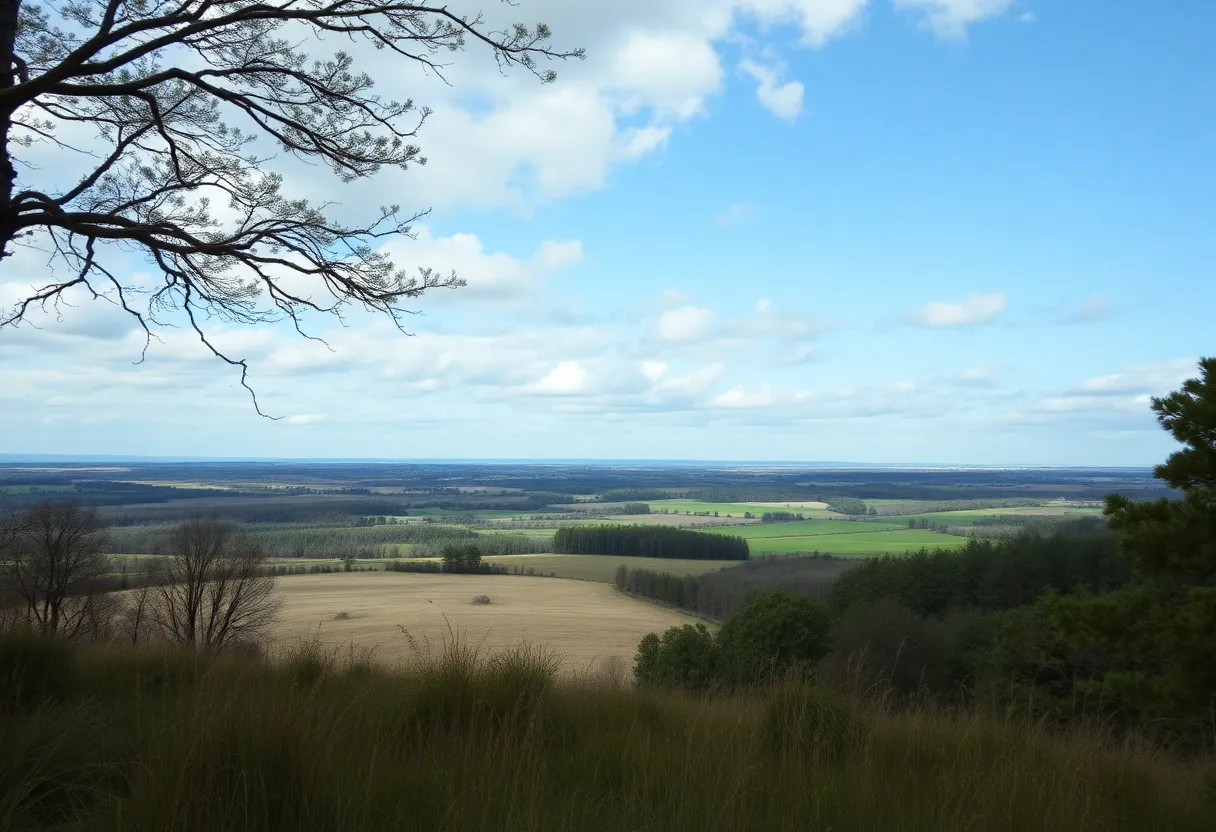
[272,572,696,671]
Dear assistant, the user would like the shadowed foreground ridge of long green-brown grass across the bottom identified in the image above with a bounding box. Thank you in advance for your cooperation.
[0,640,1216,832]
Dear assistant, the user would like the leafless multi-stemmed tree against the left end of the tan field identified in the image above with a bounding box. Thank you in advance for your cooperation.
[151,517,280,650]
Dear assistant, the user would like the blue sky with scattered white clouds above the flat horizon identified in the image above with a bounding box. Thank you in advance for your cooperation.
[0,0,1216,465]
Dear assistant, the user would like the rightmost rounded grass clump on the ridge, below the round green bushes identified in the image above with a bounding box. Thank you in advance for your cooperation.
[761,680,866,763]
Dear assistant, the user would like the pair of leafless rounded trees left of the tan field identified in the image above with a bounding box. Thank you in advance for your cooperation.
[0,500,278,650]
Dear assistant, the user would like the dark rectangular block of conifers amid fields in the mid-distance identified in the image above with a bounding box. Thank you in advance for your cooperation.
[553,525,748,561]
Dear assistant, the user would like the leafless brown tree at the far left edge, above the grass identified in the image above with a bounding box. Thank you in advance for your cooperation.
[0,500,109,637]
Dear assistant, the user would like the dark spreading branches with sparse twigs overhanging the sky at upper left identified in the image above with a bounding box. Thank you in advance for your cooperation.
[0,0,581,412]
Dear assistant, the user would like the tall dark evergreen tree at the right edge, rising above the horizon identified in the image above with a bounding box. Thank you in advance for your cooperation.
[1053,358,1216,736]
